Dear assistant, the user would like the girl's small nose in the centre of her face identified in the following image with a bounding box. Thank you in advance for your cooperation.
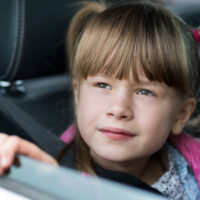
[107,96,133,121]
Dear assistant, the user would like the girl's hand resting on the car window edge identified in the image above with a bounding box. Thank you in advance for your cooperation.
[0,133,58,175]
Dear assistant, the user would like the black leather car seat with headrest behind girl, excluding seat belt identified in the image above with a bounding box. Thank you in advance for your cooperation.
[0,0,82,138]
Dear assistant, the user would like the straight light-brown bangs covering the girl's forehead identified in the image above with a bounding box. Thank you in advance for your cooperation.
[73,4,188,92]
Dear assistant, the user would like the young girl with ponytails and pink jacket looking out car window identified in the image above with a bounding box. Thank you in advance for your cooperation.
[0,2,200,199]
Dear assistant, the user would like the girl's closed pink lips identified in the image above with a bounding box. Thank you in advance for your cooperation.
[99,127,135,140]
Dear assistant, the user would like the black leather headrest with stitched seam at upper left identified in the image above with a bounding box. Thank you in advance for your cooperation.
[0,0,79,81]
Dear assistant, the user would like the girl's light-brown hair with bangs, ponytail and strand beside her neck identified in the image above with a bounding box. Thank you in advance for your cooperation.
[63,2,200,174]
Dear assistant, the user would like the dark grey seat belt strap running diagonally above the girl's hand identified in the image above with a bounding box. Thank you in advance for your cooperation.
[0,95,66,157]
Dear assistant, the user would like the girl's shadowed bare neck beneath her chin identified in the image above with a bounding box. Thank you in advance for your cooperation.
[91,153,166,185]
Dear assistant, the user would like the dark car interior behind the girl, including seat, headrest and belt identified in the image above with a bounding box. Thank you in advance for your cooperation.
[0,0,200,197]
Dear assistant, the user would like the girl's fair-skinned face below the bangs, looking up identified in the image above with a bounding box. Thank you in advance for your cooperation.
[75,75,192,166]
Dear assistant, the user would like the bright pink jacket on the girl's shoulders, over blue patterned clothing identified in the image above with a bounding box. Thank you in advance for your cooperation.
[60,124,200,189]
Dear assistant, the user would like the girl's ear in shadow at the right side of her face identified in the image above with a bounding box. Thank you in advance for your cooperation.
[171,98,196,135]
